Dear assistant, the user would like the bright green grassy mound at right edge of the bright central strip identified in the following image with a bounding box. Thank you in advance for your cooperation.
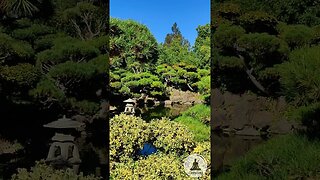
[174,104,210,142]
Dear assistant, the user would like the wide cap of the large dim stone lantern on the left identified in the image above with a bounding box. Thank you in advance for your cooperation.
[43,115,84,129]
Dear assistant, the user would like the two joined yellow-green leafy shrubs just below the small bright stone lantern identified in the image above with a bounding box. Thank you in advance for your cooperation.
[110,114,195,162]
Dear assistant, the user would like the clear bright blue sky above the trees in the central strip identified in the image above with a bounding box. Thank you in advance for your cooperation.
[110,0,210,45]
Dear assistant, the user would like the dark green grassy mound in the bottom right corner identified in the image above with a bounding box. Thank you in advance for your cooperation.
[217,134,320,180]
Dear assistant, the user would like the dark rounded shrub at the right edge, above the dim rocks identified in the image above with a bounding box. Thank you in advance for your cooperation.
[278,46,320,105]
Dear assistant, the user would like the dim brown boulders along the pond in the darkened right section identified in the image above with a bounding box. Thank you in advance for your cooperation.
[211,89,301,136]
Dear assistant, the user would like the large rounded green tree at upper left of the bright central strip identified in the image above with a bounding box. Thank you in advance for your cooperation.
[110,18,158,68]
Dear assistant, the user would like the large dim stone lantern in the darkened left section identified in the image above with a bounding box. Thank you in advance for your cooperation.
[43,116,83,174]
